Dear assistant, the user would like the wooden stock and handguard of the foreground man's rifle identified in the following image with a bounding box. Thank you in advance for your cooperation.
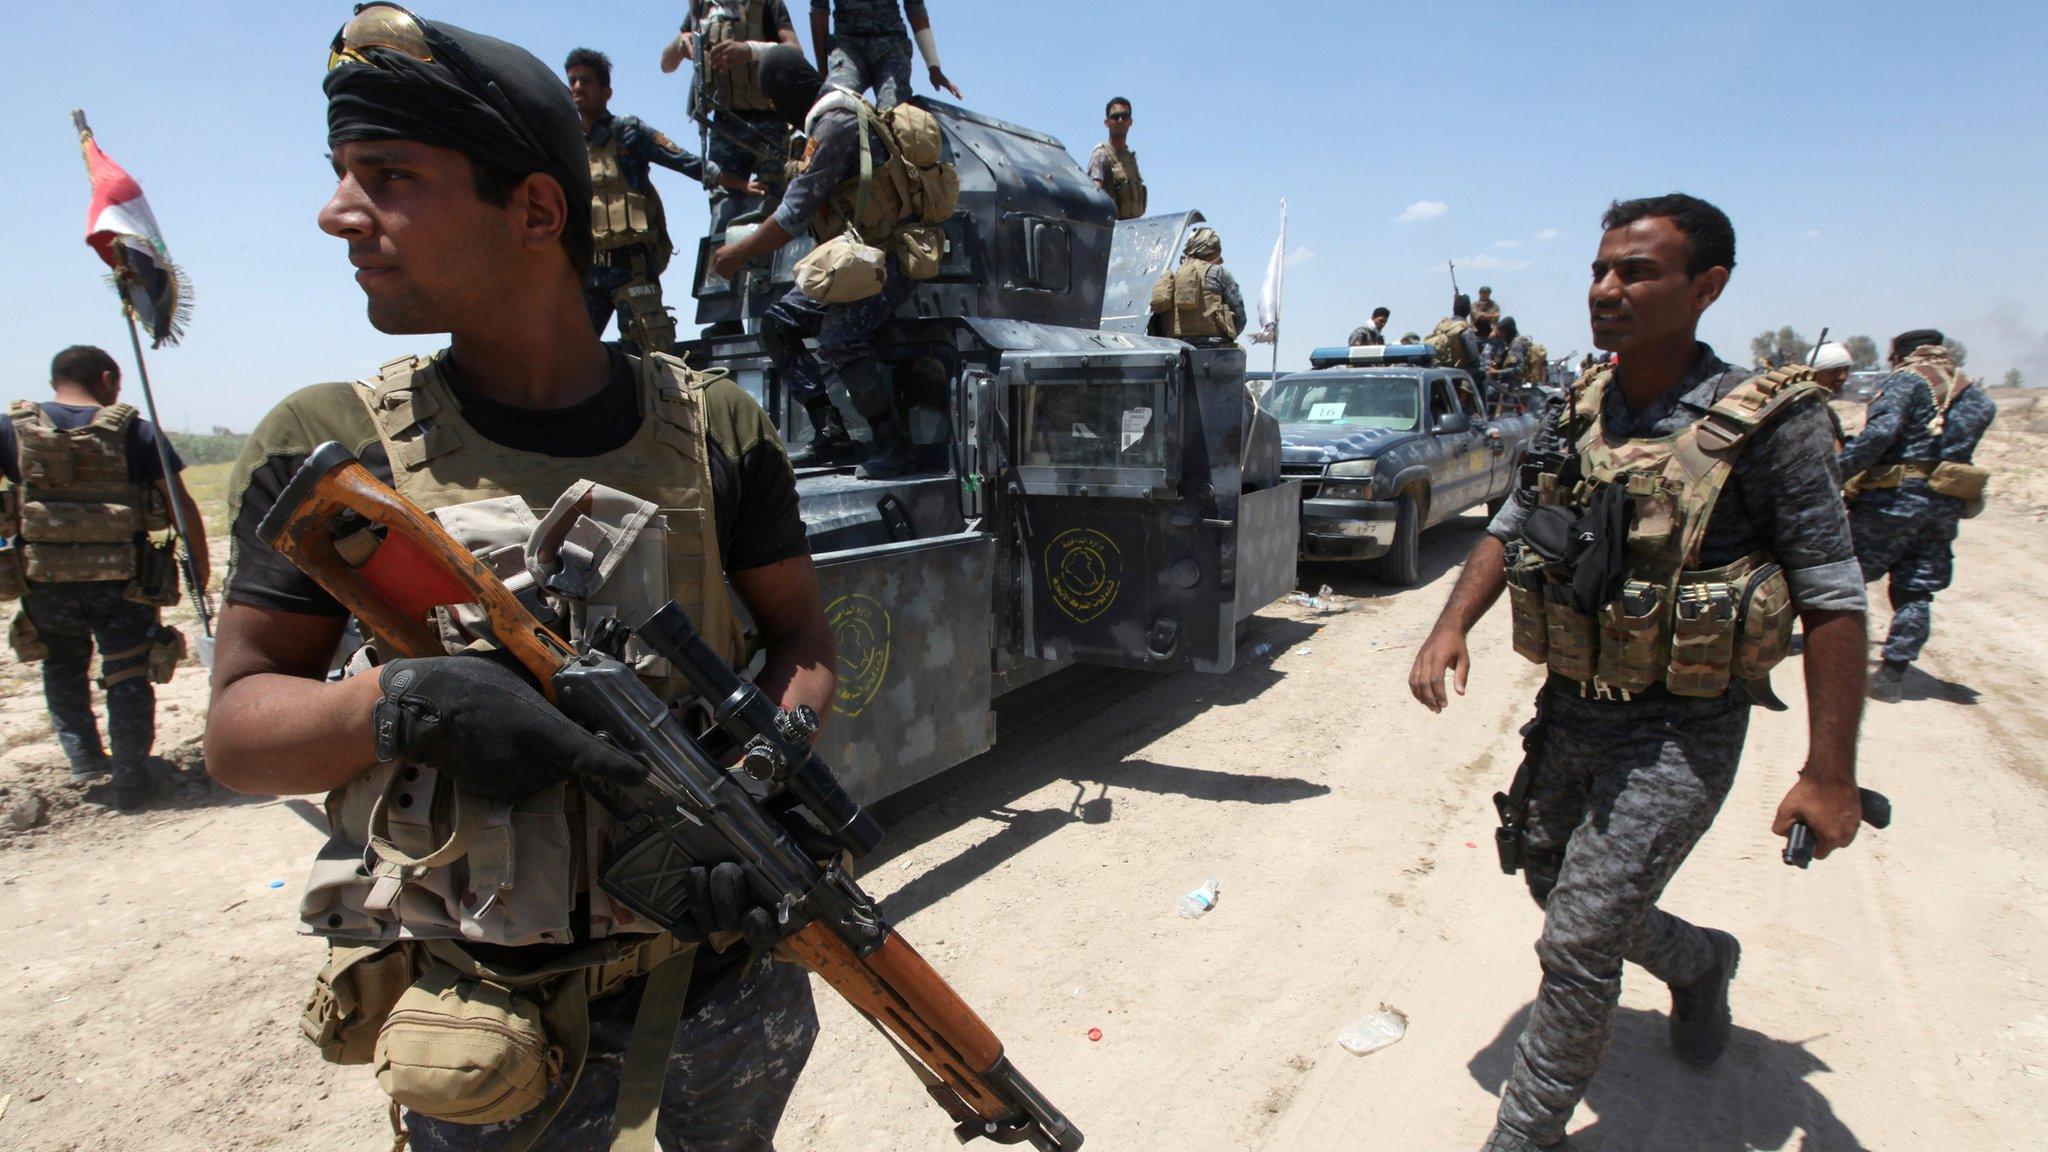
[258,443,1081,1152]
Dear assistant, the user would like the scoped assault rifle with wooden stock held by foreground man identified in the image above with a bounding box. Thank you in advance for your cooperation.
[260,443,1081,1152]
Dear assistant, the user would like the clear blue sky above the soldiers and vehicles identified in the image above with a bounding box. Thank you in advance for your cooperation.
[0,0,2048,430]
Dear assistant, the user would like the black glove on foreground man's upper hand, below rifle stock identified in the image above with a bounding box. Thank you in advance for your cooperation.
[377,654,645,799]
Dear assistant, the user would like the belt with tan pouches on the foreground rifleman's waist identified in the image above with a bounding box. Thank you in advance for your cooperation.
[299,933,698,1152]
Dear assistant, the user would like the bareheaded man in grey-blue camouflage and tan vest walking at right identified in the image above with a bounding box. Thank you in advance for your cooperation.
[1409,195,1864,1152]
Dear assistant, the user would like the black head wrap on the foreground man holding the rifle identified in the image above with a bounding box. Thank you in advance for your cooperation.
[322,16,590,205]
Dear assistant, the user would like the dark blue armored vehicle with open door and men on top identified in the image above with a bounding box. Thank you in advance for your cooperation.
[678,98,1300,801]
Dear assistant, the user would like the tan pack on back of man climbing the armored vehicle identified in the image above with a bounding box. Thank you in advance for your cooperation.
[799,88,961,247]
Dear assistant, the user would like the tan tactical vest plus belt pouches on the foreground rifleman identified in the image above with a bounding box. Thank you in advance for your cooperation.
[299,355,745,1148]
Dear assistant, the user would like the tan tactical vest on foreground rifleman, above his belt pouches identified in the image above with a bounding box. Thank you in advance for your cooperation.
[299,355,743,945]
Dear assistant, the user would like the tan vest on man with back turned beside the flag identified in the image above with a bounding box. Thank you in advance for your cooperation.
[8,400,170,584]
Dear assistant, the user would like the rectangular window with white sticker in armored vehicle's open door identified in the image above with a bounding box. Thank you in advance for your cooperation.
[1020,379,1167,467]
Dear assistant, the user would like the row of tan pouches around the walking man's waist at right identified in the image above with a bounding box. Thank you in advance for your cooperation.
[1507,547,1794,699]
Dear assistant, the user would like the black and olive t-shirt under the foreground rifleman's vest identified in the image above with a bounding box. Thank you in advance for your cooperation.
[227,346,809,617]
